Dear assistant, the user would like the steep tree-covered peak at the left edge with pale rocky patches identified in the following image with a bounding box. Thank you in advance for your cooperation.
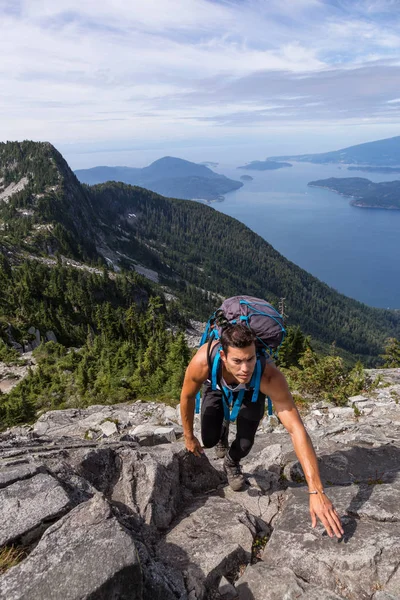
[0,142,97,259]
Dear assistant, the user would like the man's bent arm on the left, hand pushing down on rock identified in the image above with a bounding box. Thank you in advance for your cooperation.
[180,344,208,456]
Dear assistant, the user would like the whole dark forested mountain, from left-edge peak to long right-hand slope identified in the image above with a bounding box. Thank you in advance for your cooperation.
[0,142,400,363]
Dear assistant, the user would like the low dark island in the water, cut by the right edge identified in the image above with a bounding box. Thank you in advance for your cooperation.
[308,177,400,210]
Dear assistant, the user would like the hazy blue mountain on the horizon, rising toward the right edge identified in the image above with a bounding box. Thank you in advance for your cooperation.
[270,136,400,166]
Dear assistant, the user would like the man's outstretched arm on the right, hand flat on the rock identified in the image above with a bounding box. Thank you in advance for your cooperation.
[260,365,343,537]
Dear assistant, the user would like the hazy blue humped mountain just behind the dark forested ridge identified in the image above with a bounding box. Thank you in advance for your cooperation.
[75,156,243,200]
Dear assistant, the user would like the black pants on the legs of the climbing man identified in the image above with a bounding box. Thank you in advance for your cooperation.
[201,384,265,462]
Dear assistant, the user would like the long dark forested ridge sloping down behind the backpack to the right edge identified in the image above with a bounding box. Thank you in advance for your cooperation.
[90,183,400,360]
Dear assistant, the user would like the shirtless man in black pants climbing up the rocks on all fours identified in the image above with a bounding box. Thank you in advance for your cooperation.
[180,325,343,537]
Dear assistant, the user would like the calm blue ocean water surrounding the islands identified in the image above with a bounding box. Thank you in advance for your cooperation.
[212,163,400,309]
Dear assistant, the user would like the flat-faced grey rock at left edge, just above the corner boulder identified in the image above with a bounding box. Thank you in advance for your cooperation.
[0,473,71,547]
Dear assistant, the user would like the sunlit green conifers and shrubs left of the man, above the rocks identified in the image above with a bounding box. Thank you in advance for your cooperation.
[0,297,190,427]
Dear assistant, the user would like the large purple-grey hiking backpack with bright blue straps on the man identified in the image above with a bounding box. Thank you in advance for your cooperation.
[196,296,286,421]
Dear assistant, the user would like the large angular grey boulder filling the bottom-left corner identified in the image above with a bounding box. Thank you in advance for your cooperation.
[0,495,142,600]
